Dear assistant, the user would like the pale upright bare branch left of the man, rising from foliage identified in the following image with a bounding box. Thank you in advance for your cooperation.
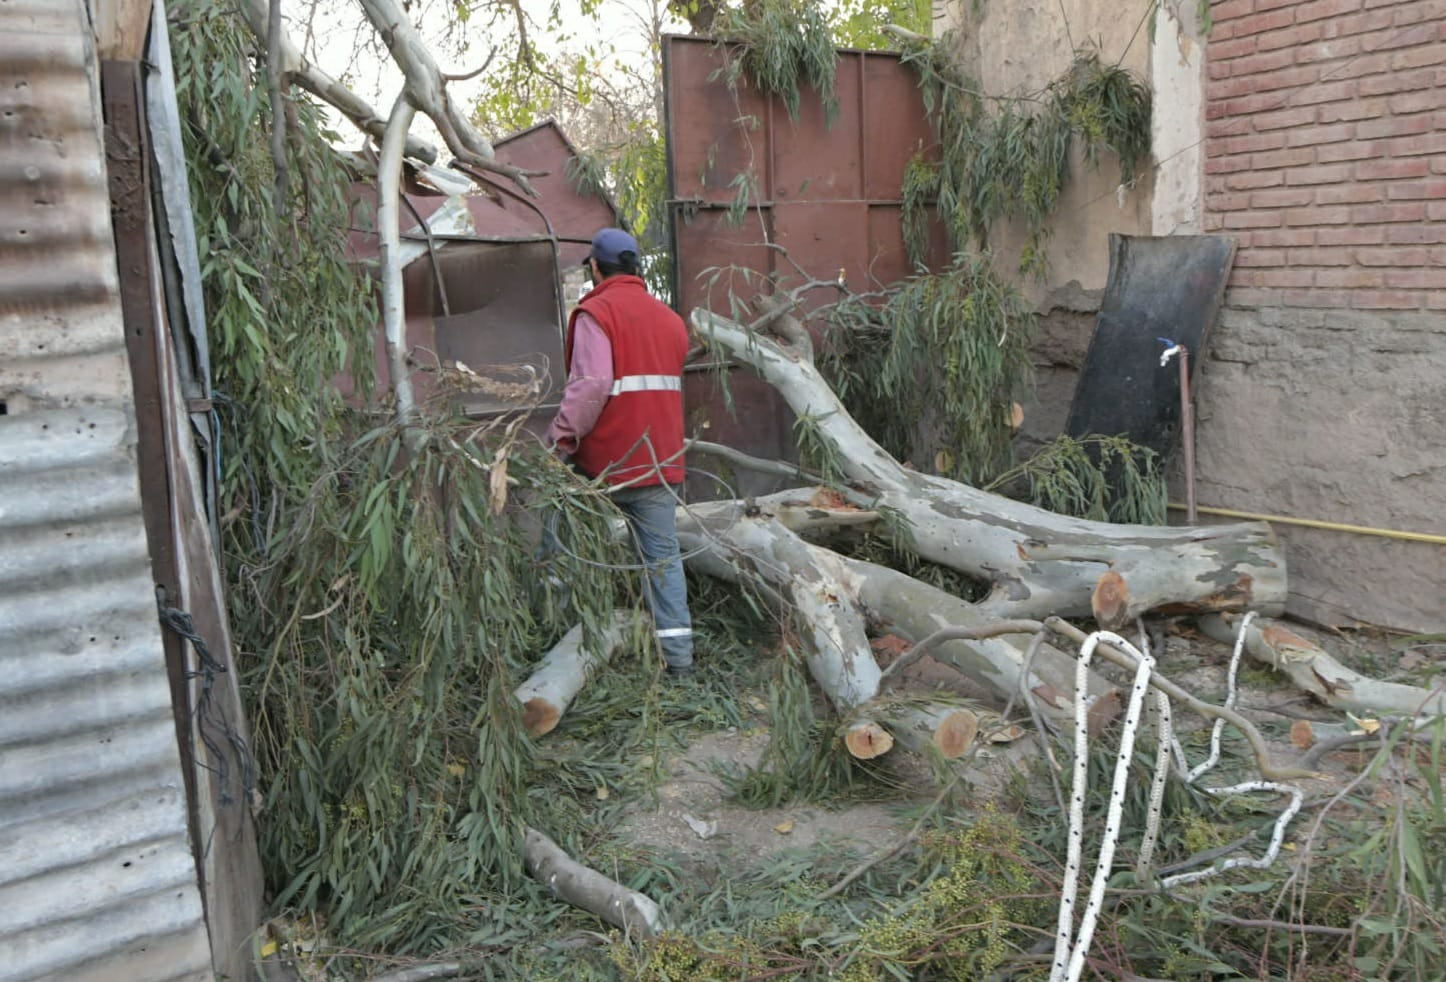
[376,90,416,424]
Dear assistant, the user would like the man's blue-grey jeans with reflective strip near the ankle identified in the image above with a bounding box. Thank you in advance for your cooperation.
[612,484,693,668]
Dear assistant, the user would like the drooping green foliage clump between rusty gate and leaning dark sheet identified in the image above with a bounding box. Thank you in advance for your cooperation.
[821,255,1034,483]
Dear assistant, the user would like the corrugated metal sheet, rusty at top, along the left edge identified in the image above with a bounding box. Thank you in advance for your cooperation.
[0,0,211,981]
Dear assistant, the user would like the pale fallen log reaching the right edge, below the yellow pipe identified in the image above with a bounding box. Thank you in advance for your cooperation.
[1200,616,1446,717]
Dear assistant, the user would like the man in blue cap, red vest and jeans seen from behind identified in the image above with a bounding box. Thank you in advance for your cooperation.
[547,229,693,675]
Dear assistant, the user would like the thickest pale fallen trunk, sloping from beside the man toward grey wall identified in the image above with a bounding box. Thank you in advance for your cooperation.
[693,309,1285,618]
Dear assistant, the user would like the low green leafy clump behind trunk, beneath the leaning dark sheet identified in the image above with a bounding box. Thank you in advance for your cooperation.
[985,434,1168,525]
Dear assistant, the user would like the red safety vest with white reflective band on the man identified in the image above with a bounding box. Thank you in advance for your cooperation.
[565,276,688,486]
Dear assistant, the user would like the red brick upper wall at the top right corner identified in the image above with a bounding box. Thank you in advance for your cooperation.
[1205,0,1446,311]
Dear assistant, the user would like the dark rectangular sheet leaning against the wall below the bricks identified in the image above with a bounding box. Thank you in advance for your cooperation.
[1064,234,1235,454]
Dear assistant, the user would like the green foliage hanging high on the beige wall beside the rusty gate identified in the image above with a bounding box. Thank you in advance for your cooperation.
[904,38,1150,275]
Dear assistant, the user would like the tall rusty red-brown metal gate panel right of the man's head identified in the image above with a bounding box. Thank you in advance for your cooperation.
[664,38,949,496]
